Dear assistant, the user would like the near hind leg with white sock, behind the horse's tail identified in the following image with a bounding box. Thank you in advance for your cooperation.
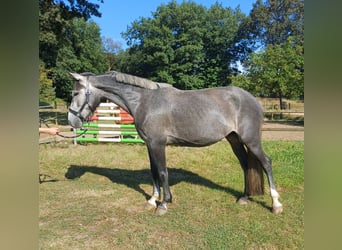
[246,140,283,214]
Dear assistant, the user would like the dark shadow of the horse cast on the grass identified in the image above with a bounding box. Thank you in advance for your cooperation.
[65,165,246,204]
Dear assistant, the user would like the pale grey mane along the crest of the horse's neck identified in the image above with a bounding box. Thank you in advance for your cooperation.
[109,71,172,89]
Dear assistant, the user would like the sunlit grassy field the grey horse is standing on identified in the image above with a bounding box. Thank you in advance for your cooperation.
[39,141,304,249]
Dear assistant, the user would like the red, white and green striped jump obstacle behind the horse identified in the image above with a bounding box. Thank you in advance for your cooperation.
[74,103,144,144]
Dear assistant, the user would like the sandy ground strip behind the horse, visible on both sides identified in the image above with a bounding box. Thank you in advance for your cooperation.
[39,122,304,143]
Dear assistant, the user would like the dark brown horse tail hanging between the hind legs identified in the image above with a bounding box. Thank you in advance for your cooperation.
[246,150,264,196]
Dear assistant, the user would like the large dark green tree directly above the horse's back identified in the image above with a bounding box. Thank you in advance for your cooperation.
[121,1,244,89]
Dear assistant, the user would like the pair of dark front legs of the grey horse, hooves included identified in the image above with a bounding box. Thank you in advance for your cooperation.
[148,143,172,215]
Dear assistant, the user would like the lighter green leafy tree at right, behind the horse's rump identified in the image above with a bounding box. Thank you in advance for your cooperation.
[233,38,304,108]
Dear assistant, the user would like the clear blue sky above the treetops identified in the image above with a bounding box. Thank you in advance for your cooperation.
[92,0,256,47]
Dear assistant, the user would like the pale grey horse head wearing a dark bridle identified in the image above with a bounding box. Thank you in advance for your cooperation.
[68,73,100,128]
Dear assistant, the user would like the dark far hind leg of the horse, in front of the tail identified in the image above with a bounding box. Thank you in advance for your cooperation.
[226,132,248,205]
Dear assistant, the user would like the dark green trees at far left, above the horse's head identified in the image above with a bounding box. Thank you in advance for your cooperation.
[39,0,106,101]
